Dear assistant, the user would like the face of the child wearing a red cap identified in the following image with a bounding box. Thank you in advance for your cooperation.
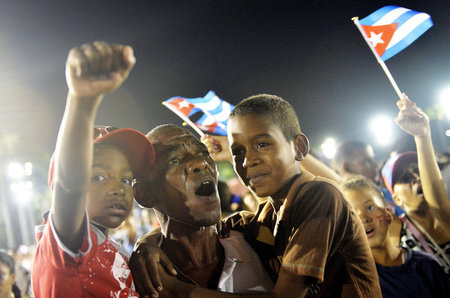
[87,145,133,228]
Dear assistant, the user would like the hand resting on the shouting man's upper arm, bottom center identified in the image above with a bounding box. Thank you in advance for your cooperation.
[129,231,177,297]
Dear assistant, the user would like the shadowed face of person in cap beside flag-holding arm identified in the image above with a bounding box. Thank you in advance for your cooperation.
[394,163,425,210]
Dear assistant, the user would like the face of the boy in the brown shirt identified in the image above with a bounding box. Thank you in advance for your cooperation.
[228,114,300,197]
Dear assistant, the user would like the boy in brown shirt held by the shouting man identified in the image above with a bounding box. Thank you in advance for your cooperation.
[135,94,381,297]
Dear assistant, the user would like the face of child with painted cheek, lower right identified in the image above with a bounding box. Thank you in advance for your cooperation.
[345,188,392,248]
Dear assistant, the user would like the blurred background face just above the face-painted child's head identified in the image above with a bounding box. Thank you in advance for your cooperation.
[350,146,378,182]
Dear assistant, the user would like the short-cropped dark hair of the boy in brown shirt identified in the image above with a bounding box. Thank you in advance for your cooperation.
[230,94,302,141]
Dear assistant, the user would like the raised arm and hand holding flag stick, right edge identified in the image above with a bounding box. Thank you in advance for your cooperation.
[395,94,450,214]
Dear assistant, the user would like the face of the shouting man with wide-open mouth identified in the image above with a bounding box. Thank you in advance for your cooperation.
[149,127,221,226]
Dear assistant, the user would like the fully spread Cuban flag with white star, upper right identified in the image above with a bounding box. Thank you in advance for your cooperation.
[359,5,433,61]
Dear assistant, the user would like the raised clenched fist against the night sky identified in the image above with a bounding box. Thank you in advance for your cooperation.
[66,41,136,98]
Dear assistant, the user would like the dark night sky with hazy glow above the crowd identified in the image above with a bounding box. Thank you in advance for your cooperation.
[0,0,450,168]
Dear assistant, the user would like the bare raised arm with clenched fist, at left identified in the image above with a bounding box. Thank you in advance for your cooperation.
[51,42,135,251]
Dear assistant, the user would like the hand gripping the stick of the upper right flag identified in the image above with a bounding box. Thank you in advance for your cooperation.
[395,93,430,137]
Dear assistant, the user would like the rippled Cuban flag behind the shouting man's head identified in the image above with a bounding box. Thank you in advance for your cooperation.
[163,91,234,135]
